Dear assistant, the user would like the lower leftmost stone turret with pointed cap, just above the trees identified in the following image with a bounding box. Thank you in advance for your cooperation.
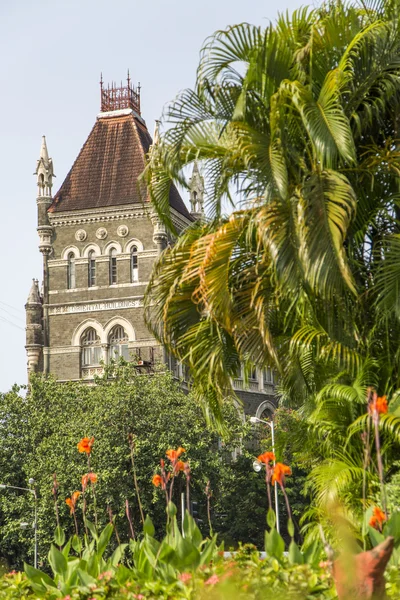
[25,279,43,377]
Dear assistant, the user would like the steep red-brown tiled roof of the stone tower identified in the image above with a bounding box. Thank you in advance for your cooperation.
[49,113,191,219]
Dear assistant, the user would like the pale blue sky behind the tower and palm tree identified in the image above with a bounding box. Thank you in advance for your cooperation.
[0,0,302,391]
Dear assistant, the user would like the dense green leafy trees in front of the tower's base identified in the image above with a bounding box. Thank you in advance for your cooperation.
[0,365,310,567]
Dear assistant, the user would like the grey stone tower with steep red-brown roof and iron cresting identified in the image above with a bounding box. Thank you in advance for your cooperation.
[26,75,193,381]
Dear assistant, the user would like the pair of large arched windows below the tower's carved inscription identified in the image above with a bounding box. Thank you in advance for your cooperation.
[81,325,129,367]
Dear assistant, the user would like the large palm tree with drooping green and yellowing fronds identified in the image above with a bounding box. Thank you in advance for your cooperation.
[144,0,400,427]
